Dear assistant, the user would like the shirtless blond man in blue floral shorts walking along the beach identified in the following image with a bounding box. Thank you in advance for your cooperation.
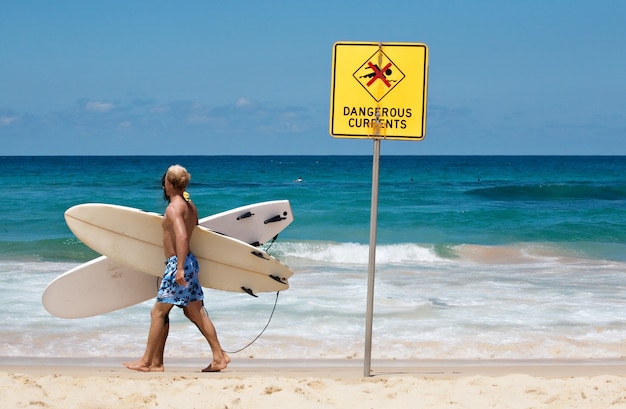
[123,165,230,372]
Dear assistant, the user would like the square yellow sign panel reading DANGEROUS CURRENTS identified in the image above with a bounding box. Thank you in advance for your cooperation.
[330,42,428,140]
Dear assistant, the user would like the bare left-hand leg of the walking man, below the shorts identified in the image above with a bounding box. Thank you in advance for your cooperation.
[123,302,173,372]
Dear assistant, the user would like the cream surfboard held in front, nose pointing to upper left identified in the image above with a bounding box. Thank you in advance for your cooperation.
[65,203,293,293]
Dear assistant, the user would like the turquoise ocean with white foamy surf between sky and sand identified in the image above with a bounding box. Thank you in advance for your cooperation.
[0,155,626,365]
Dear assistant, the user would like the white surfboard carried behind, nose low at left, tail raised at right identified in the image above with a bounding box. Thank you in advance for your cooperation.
[42,200,293,318]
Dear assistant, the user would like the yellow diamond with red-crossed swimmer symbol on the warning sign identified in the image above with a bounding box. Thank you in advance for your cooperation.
[352,51,405,102]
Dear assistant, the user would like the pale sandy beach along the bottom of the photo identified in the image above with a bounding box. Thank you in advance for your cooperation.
[0,358,626,409]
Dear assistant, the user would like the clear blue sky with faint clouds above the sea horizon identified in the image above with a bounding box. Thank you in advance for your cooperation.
[0,0,626,155]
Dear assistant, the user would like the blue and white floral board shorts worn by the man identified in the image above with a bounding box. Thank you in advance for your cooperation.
[156,253,204,307]
